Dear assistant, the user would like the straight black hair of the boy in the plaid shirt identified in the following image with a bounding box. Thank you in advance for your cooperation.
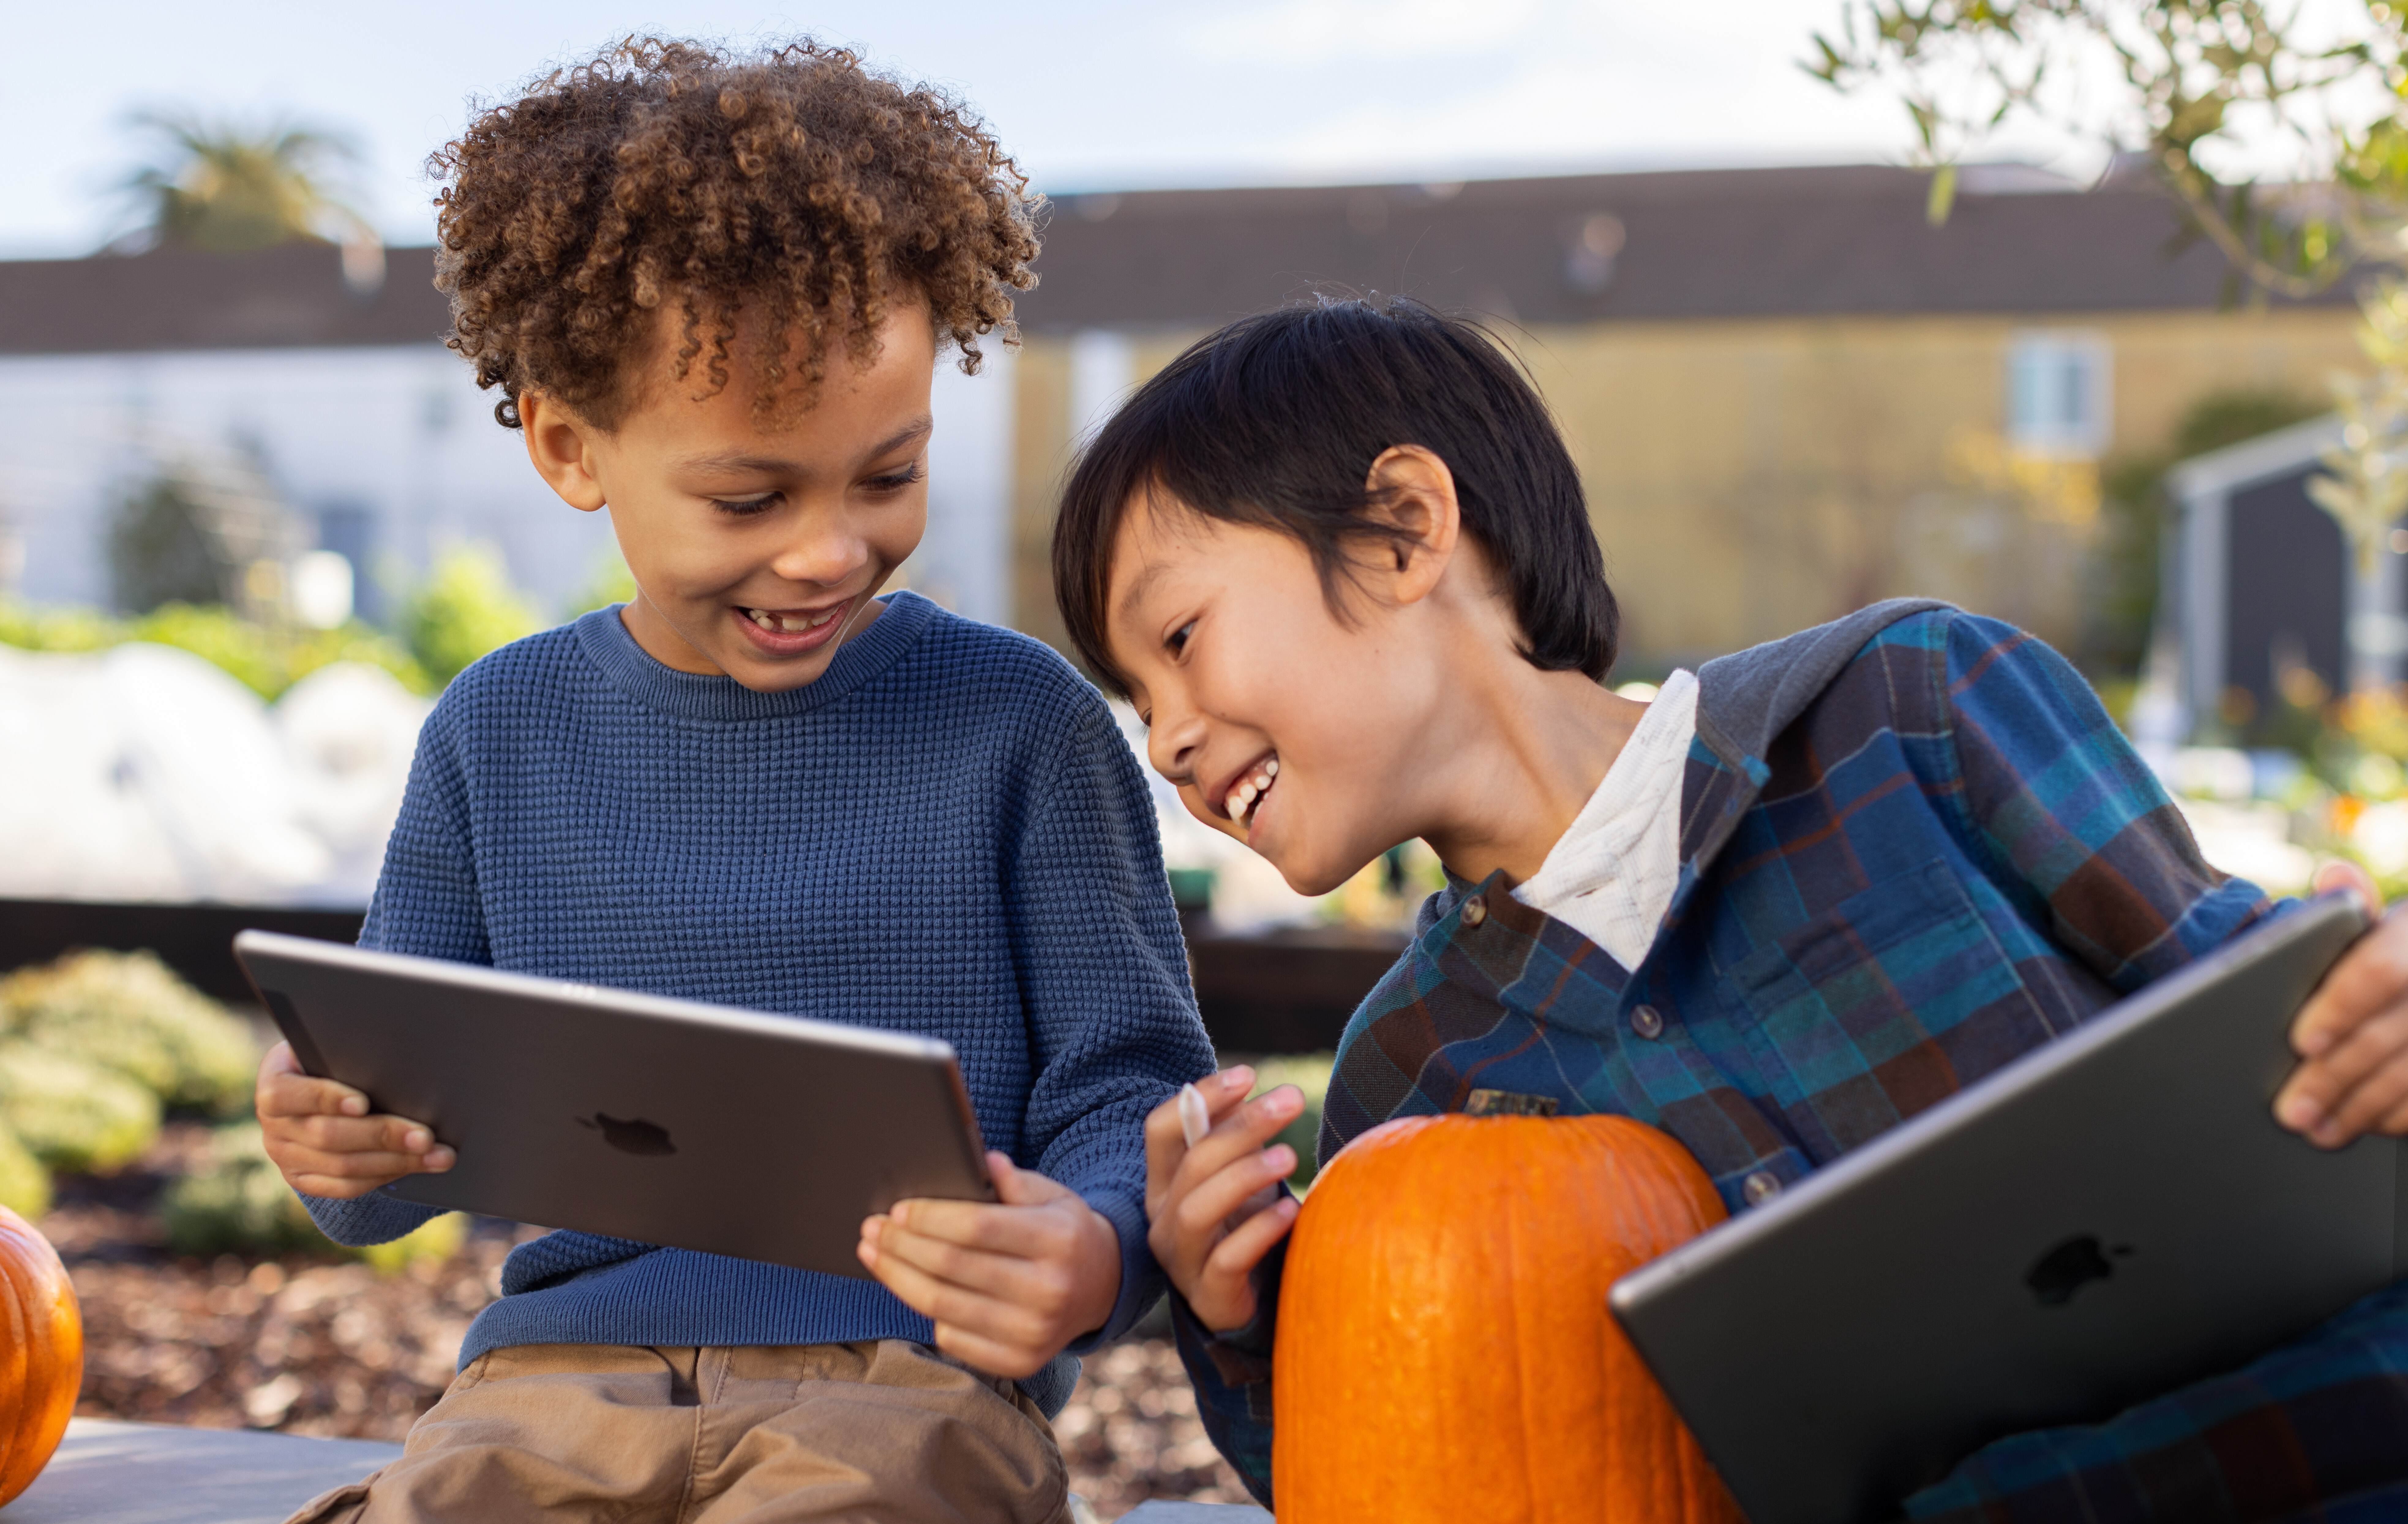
[1052,296,1621,693]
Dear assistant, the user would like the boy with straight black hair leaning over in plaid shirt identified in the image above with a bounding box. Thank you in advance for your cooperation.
[1055,301,2408,1524]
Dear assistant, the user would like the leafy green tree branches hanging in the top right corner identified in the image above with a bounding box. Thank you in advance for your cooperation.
[1806,0,2408,566]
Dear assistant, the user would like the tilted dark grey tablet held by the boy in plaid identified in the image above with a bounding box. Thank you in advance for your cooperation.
[1613,898,2408,1524]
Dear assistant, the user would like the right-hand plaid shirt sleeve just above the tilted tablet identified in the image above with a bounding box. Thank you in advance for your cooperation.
[1941,614,2268,994]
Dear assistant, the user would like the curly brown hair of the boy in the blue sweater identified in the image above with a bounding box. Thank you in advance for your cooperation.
[429,39,1043,429]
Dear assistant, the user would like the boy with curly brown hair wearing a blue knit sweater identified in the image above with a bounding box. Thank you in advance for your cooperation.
[258,43,1211,1522]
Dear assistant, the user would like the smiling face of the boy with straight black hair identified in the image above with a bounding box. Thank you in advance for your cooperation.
[1108,498,1445,893]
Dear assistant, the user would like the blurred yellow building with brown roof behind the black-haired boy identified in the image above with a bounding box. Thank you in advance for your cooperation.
[1014,166,2360,669]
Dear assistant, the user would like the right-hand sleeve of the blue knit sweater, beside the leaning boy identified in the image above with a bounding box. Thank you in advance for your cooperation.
[1007,693,1213,1353]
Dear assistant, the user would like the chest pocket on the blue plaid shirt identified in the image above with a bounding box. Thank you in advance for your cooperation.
[1729,859,2052,1163]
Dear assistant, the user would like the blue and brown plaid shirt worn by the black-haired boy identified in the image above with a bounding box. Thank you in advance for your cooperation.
[1173,602,2408,1524]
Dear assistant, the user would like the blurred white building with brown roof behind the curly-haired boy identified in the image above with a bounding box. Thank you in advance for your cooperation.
[0,243,1011,621]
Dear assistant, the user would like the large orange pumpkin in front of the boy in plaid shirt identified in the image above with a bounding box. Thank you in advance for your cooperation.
[1271,1115,1741,1524]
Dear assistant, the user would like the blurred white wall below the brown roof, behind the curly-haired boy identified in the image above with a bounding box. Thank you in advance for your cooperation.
[0,344,1011,621]
